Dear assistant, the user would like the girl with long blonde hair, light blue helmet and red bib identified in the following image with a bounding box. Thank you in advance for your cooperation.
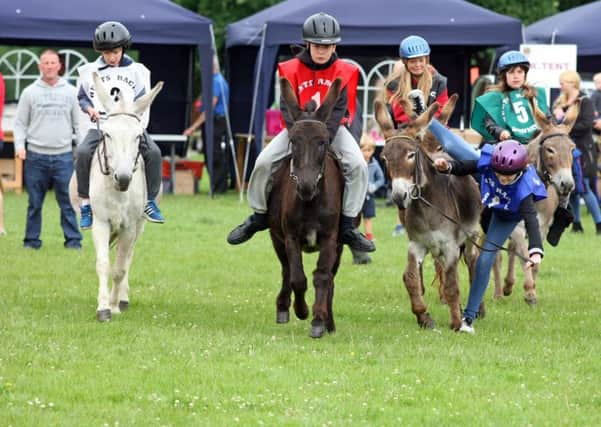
[386,35,449,125]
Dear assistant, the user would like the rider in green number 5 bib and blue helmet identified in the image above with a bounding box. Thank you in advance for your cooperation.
[472,50,548,144]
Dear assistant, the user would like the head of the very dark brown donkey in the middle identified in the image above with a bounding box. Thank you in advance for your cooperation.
[280,78,342,201]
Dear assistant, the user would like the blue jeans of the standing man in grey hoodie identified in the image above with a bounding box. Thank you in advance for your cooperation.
[23,151,81,249]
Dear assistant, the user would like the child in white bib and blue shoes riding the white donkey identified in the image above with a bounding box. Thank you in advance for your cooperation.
[75,21,164,230]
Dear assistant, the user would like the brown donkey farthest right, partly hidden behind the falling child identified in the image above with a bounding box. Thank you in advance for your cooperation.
[493,102,580,305]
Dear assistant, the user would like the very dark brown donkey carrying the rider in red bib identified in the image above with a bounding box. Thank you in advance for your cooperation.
[269,79,344,338]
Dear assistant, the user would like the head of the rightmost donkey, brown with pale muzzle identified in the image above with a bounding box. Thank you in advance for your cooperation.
[528,101,580,196]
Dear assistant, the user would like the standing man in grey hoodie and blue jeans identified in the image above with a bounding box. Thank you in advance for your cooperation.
[13,50,81,249]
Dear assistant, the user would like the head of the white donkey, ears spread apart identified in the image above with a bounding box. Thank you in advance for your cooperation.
[93,73,163,191]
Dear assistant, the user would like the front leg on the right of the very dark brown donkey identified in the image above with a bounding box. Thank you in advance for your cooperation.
[311,238,339,338]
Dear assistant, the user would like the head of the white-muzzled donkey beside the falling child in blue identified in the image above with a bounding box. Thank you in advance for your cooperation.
[374,101,439,208]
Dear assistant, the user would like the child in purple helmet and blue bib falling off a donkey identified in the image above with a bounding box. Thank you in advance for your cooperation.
[430,120,547,334]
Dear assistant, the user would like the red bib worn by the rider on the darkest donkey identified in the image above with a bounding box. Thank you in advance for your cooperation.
[278,58,359,125]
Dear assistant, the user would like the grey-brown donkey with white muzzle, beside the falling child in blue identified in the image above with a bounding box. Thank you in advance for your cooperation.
[375,101,481,330]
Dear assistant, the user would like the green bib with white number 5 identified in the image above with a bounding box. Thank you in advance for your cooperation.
[472,88,547,144]
